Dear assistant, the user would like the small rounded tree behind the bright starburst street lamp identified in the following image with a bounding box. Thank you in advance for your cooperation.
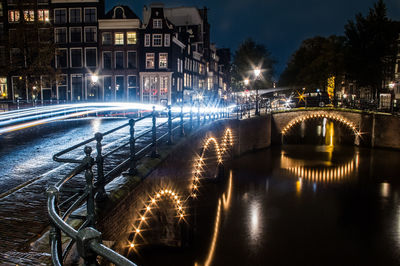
[231,38,275,91]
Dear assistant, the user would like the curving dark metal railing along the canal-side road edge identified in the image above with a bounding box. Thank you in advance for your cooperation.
[47,106,229,265]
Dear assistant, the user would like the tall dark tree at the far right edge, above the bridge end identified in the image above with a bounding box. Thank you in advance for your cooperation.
[345,0,399,99]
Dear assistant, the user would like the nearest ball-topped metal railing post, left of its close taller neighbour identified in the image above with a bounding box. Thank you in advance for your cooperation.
[84,146,95,227]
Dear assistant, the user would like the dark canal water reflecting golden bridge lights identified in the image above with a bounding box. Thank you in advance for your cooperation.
[129,121,400,265]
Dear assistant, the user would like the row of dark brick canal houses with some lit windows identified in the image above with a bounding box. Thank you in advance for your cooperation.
[0,0,230,104]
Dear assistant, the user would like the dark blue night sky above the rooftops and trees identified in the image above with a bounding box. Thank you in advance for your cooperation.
[106,0,400,78]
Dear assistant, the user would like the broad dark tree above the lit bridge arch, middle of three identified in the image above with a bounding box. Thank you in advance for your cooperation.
[279,35,345,90]
